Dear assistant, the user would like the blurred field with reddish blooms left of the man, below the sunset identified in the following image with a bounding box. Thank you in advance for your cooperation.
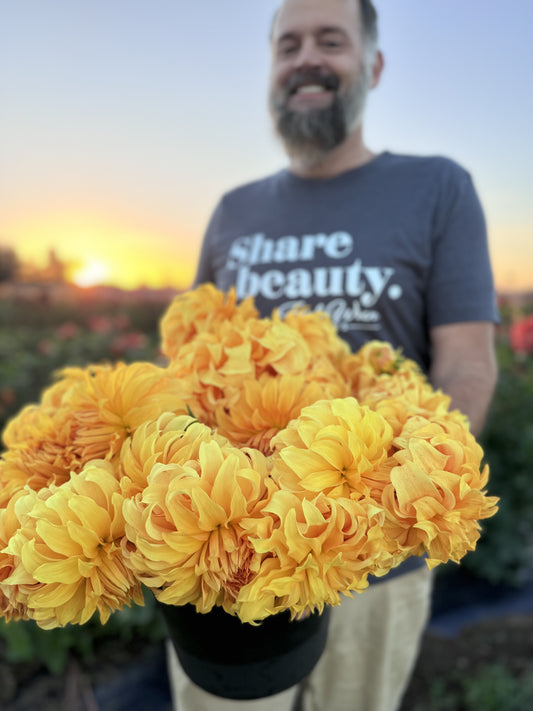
[0,290,166,429]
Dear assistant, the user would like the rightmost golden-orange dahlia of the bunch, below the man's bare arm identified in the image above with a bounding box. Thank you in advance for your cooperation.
[382,417,498,567]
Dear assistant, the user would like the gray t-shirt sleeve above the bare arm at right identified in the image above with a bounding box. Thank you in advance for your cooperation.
[427,166,498,328]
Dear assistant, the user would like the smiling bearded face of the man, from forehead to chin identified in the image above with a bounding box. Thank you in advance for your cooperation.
[269,0,369,163]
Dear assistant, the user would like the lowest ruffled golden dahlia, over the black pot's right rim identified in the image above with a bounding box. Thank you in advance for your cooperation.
[237,490,393,622]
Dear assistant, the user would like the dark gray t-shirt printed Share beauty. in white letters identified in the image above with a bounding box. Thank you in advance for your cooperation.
[195,152,497,370]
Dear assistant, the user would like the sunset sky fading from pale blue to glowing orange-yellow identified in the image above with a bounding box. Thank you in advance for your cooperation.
[0,0,533,289]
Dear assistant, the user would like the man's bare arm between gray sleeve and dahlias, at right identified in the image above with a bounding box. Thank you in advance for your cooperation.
[429,321,498,437]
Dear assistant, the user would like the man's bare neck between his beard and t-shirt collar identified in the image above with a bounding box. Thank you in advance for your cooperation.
[289,126,375,178]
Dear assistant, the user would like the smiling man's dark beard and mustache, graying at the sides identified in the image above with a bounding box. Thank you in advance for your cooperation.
[270,69,368,165]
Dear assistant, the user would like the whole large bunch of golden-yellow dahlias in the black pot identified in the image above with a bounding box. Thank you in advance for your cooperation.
[0,285,496,629]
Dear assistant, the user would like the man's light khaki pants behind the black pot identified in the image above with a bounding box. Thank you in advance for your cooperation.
[168,567,432,711]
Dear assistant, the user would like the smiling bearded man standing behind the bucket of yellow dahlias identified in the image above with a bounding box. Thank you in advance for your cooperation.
[169,0,497,711]
